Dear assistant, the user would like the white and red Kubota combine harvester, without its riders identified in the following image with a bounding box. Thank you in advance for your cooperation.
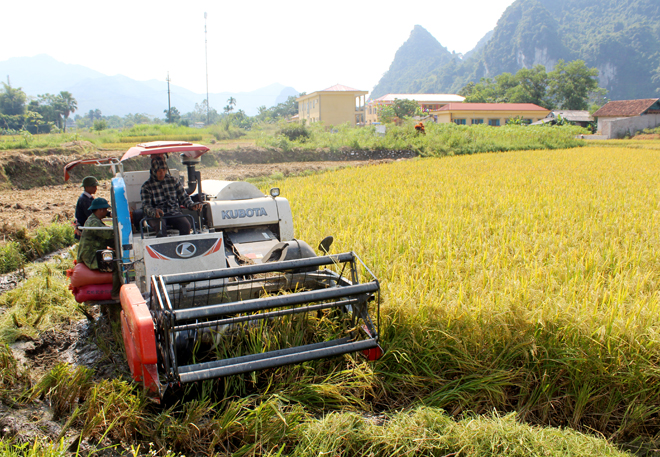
[65,142,382,398]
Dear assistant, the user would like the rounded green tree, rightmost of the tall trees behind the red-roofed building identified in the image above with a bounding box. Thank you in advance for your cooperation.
[548,60,605,110]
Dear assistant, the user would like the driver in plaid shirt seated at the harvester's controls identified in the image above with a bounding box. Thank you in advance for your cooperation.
[140,154,202,236]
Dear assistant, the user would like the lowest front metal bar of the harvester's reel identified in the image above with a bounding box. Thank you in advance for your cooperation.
[179,338,378,382]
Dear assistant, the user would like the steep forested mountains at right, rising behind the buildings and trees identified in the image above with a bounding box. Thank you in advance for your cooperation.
[372,0,660,100]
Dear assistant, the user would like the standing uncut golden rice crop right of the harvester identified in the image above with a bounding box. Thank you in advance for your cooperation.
[280,147,660,439]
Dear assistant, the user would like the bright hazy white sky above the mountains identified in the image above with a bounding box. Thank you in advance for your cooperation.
[0,0,513,93]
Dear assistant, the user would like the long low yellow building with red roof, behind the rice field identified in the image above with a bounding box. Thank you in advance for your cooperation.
[431,103,550,127]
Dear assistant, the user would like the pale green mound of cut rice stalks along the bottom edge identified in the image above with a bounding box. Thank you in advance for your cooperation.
[289,407,630,457]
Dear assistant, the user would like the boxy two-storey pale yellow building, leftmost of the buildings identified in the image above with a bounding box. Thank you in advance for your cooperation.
[296,84,369,126]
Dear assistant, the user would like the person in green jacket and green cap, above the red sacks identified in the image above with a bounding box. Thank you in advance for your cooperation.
[78,198,121,300]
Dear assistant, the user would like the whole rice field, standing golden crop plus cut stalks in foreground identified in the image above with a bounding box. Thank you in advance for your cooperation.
[0,146,660,456]
